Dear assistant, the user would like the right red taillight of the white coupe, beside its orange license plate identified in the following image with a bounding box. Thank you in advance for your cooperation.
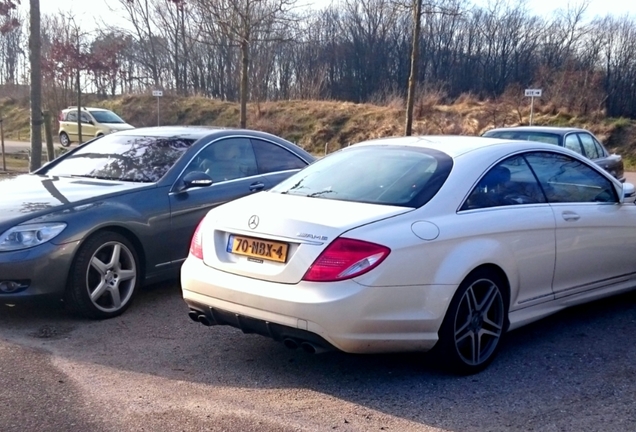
[303,238,391,282]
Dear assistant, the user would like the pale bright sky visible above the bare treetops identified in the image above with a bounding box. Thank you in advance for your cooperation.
[33,0,636,27]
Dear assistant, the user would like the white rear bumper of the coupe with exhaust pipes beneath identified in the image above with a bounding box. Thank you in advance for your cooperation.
[181,258,456,353]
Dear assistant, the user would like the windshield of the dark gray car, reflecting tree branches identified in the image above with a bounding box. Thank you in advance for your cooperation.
[41,135,194,182]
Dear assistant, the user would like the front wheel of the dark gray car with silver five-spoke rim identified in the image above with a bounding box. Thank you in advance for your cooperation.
[66,231,140,319]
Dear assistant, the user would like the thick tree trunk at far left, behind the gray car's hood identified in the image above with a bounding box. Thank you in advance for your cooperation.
[29,0,42,172]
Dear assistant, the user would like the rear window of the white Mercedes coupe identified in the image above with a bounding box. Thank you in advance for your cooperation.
[272,146,453,207]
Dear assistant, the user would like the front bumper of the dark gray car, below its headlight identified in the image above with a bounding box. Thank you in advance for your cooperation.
[0,241,79,303]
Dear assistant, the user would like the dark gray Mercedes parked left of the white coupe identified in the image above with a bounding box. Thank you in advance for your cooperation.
[0,127,314,319]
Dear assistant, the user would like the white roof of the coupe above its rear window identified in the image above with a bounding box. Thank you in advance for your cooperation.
[352,135,555,158]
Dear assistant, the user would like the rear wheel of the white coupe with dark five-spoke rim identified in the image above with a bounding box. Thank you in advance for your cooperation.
[435,269,508,375]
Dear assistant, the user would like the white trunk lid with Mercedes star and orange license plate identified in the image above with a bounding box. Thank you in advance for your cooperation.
[202,192,413,284]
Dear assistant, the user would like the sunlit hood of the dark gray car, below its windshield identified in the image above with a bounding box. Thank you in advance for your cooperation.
[0,174,154,227]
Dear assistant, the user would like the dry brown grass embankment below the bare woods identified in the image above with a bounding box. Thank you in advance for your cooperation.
[0,95,636,165]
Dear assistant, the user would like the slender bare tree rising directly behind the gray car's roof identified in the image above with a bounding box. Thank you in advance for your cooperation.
[195,0,296,128]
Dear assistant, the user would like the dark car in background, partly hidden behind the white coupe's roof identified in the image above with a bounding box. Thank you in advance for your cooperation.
[483,126,625,182]
